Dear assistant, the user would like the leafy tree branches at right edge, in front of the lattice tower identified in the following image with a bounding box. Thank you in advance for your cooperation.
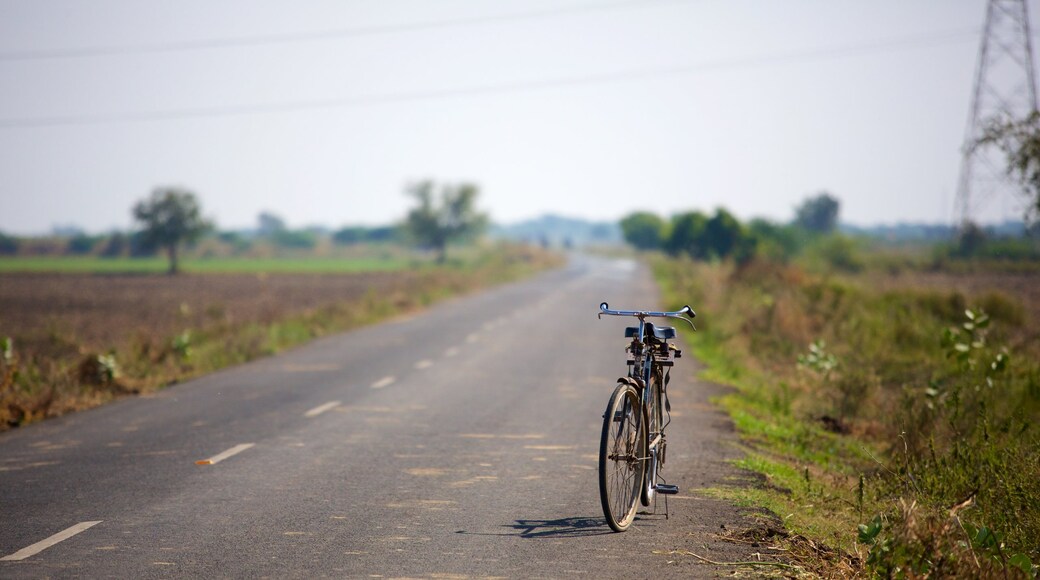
[965,111,1040,226]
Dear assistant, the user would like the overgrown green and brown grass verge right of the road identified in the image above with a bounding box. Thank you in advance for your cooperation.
[653,260,1040,577]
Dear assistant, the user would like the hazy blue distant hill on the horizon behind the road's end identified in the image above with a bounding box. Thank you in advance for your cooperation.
[489,214,623,247]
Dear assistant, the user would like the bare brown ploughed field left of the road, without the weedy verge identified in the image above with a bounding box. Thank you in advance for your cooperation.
[0,272,417,353]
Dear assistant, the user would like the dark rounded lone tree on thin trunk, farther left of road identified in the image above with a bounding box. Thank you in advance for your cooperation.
[133,187,211,274]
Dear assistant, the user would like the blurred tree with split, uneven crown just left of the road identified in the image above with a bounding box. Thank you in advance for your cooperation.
[405,180,488,262]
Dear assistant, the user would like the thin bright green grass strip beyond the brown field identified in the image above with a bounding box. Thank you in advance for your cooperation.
[0,257,412,273]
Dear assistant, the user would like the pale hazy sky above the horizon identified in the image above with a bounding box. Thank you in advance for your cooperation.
[0,0,1036,234]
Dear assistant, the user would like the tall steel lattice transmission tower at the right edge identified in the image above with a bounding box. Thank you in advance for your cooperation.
[955,0,1037,227]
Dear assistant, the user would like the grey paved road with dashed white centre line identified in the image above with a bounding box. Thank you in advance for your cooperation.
[0,258,773,578]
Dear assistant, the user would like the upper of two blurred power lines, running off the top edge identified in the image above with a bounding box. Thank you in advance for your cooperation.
[0,0,690,62]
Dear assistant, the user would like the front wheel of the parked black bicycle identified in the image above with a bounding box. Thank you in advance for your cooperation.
[599,384,647,531]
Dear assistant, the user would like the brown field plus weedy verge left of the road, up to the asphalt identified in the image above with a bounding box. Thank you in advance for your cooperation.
[0,247,561,430]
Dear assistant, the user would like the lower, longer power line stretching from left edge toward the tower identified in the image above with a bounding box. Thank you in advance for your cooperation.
[0,29,979,129]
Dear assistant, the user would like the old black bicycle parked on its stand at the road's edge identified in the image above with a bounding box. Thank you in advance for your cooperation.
[597,302,697,532]
